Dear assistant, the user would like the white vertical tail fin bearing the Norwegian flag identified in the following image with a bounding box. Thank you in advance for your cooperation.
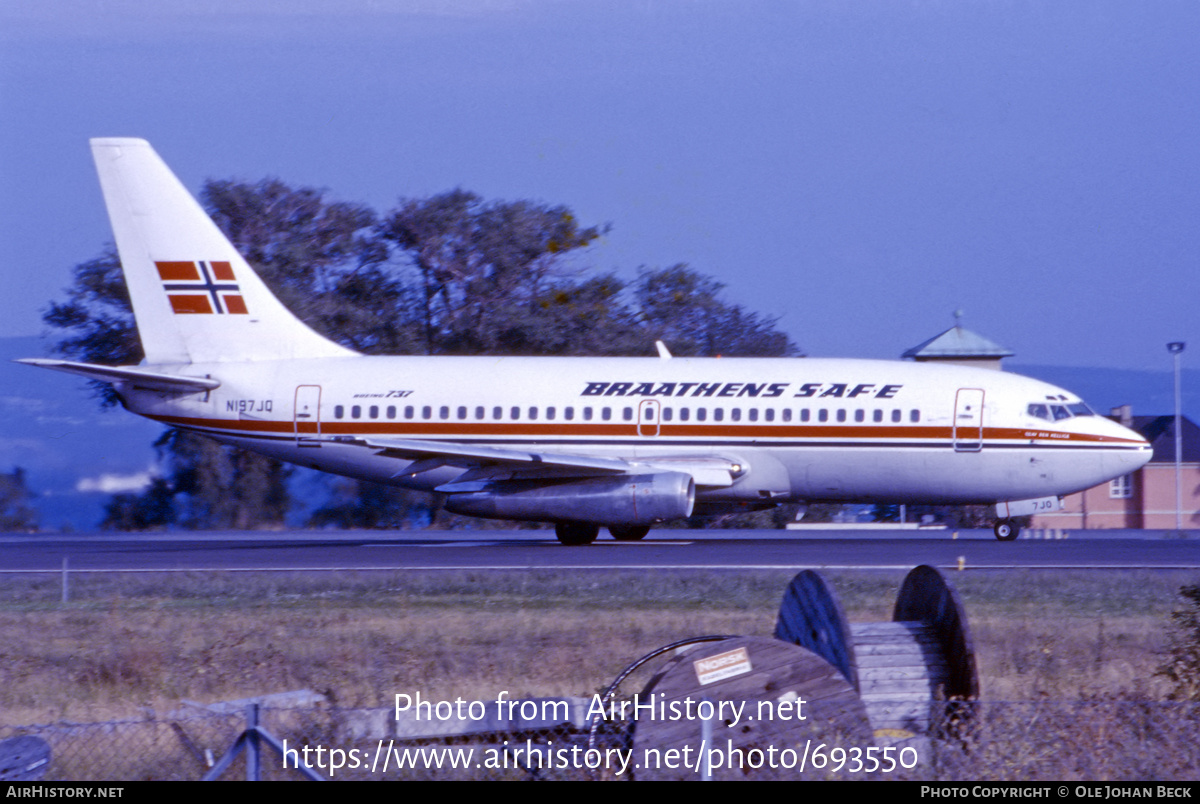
[91,138,356,365]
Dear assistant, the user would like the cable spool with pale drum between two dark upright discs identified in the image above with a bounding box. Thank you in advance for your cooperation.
[775,565,979,738]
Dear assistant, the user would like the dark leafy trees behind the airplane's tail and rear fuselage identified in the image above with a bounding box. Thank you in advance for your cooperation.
[44,179,797,529]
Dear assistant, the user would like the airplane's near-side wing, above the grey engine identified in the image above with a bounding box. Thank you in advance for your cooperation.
[364,438,739,492]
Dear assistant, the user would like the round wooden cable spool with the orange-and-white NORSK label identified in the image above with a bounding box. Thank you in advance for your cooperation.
[631,636,871,779]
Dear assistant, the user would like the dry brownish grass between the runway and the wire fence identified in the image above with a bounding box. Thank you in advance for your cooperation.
[0,570,1195,726]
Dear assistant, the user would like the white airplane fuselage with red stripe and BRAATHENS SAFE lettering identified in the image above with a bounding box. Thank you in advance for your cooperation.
[118,356,1151,503]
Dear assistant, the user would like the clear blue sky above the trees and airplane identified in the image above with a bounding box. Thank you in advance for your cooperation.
[0,0,1200,370]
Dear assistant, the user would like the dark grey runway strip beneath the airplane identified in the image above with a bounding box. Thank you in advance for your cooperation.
[0,530,1200,572]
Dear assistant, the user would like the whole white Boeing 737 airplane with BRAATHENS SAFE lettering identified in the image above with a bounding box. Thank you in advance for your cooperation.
[22,139,1151,545]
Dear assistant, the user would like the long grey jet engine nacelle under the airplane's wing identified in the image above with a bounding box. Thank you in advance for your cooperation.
[446,472,696,526]
